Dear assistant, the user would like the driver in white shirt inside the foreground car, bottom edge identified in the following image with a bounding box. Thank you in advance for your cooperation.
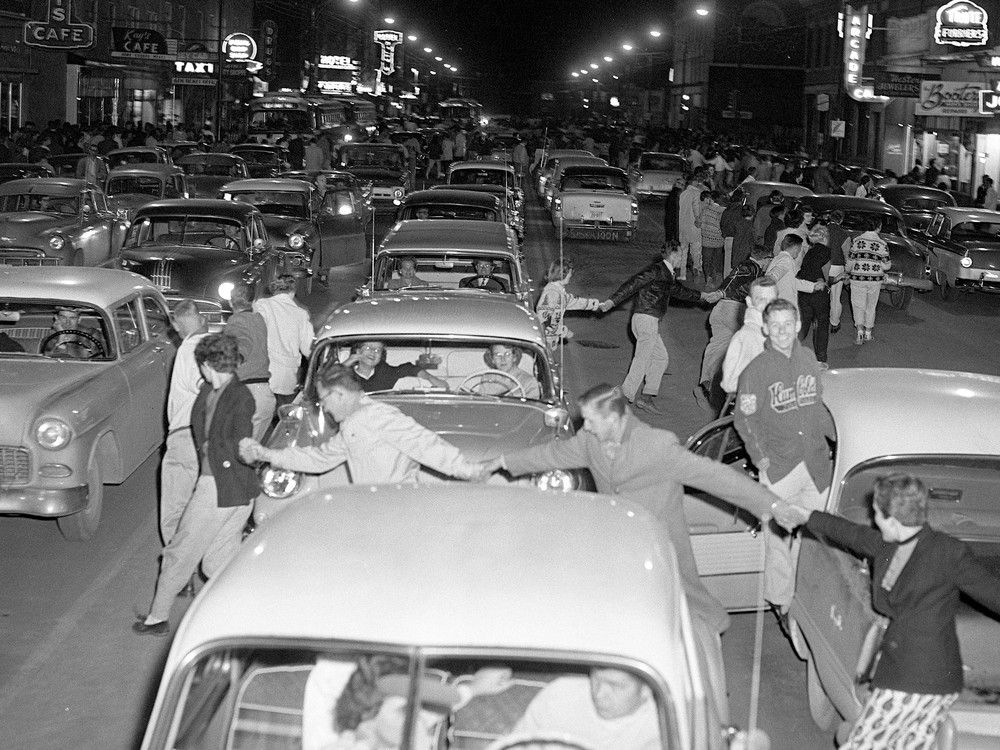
[509,667,662,750]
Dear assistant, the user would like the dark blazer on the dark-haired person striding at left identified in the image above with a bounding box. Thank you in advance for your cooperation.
[191,378,258,508]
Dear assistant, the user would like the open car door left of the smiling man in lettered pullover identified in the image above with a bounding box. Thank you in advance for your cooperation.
[684,417,764,611]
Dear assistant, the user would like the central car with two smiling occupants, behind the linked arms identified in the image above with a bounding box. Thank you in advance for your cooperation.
[255,294,576,522]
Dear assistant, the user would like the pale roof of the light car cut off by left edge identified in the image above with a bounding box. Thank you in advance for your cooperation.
[0,266,159,308]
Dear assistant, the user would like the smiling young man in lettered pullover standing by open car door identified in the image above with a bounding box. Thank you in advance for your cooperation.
[734,299,834,615]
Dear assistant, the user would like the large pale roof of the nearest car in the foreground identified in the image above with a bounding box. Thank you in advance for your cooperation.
[172,484,686,676]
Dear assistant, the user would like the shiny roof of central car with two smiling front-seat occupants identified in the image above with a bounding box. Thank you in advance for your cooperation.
[316,290,545,347]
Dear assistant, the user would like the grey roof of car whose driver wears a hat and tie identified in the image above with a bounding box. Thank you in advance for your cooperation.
[379,219,516,254]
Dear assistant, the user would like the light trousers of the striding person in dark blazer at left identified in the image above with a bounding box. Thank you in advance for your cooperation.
[149,476,253,620]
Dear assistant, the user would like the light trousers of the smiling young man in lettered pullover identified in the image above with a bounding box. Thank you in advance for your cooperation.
[760,463,826,607]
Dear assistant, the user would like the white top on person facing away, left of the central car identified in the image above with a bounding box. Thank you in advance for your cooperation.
[253,292,313,396]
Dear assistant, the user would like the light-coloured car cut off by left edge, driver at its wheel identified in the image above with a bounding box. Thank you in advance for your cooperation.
[0,266,174,539]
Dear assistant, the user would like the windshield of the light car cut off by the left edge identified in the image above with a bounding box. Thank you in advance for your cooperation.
[0,298,113,360]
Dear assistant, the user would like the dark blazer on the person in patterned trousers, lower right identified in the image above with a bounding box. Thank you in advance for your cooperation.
[807,512,1000,695]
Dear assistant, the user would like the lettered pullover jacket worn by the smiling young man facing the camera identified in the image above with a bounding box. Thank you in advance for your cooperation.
[734,341,833,490]
